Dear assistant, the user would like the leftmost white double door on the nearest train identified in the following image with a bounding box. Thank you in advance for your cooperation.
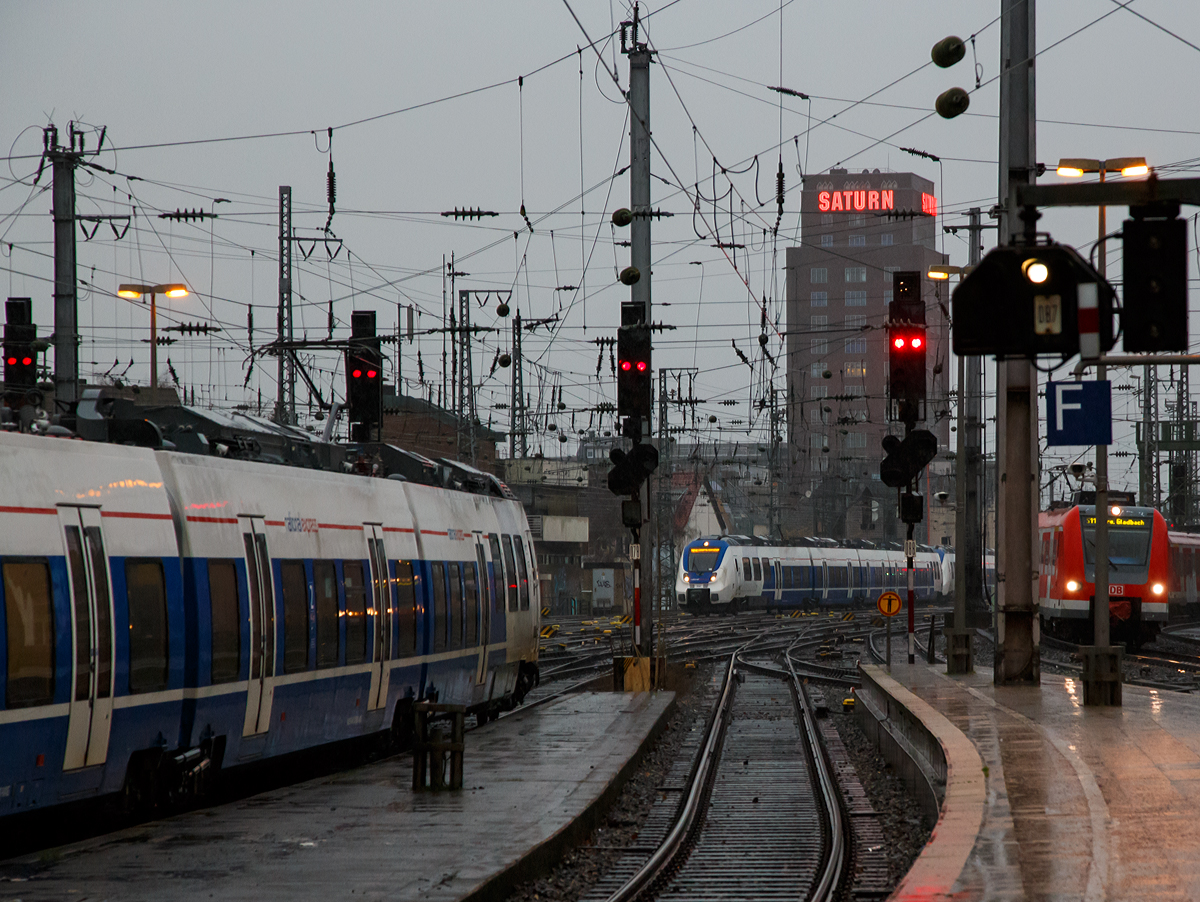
[59,506,115,770]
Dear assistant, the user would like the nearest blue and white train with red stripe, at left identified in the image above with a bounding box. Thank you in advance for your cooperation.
[0,433,541,817]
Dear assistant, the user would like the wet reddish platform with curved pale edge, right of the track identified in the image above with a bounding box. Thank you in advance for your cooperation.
[862,663,1200,902]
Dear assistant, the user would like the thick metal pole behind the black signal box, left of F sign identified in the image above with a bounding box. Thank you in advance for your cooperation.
[994,0,1040,685]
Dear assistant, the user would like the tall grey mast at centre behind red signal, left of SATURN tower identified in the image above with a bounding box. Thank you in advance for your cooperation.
[629,44,654,655]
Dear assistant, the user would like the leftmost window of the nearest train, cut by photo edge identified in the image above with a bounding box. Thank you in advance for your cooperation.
[4,558,54,708]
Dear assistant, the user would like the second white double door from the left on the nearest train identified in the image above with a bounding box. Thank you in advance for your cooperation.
[239,516,275,736]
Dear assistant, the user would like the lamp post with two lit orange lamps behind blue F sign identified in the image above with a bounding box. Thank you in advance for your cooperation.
[1057,157,1150,705]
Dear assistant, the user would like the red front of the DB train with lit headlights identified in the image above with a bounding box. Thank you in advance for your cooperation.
[1038,505,1166,647]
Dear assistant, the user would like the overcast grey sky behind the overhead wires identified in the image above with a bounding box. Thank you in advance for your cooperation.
[0,0,1200,487]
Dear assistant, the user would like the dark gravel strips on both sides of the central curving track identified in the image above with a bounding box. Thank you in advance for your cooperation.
[508,666,931,902]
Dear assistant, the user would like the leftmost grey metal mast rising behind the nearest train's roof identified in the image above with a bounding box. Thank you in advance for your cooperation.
[47,126,79,416]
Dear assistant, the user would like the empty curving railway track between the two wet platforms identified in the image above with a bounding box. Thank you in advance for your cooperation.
[584,633,847,902]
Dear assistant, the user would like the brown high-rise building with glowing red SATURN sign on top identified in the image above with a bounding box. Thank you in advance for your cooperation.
[782,169,950,542]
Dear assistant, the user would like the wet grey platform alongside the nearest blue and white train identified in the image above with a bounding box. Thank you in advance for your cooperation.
[0,692,674,902]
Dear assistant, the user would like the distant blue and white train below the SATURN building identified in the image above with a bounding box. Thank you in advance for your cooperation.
[676,536,954,613]
